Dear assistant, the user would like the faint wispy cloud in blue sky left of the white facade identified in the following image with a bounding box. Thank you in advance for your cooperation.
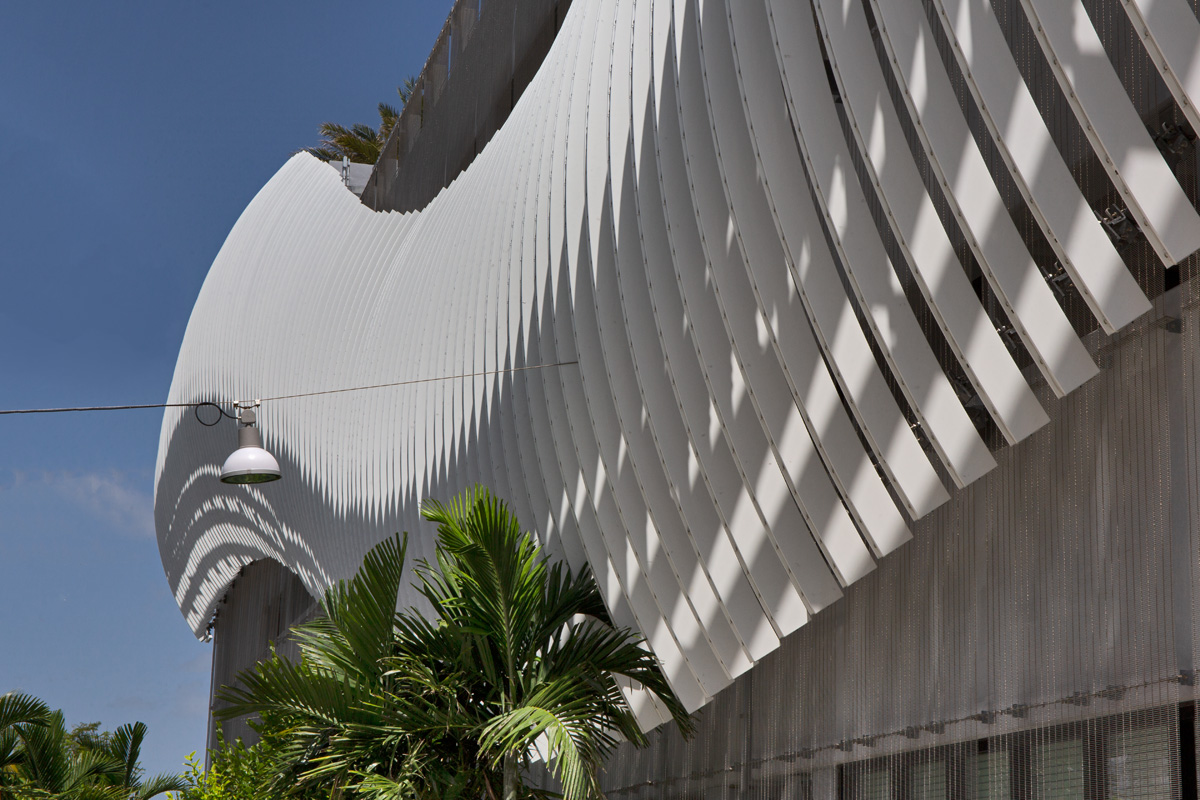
[0,470,155,539]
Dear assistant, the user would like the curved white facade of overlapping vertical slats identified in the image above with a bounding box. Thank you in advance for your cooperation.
[156,0,1200,723]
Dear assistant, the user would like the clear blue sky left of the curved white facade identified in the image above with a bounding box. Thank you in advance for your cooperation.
[0,0,451,771]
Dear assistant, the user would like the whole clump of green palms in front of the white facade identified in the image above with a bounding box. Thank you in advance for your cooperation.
[213,491,691,800]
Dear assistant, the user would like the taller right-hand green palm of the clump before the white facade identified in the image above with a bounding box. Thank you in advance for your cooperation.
[412,491,691,800]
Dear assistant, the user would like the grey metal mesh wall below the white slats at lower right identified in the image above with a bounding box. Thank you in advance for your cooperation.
[606,281,1200,786]
